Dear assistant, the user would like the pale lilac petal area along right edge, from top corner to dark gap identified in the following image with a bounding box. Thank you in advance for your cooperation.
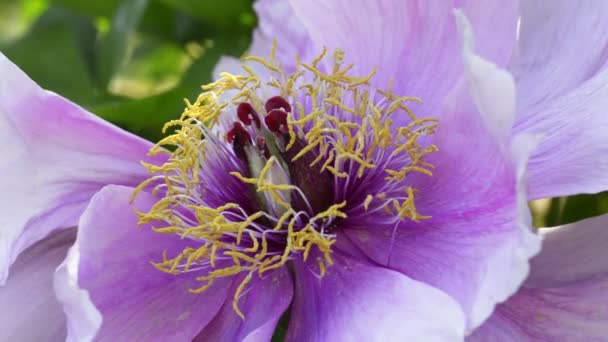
[513,0,608,199]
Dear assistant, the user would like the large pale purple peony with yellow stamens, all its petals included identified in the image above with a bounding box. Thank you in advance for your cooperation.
[0,0,608,341]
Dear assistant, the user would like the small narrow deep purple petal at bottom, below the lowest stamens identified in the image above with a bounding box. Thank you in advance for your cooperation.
[194,268,293,342]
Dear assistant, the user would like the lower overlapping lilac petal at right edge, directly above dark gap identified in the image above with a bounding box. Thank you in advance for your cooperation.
[515,69,608,199]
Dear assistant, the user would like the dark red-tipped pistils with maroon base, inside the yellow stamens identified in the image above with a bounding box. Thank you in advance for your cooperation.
[226,96,333,216]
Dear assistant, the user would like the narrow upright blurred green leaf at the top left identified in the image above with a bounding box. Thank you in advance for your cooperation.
[97,0,148,88]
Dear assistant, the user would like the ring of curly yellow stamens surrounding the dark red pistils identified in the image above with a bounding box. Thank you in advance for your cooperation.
[133,42,437,319]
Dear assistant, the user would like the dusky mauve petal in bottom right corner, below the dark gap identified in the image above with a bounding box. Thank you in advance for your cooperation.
[468,215,608,341]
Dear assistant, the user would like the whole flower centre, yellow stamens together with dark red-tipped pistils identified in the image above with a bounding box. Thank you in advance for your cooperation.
[135,44,437,318]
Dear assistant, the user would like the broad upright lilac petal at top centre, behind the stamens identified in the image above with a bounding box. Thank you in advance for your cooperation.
[291,0,517,116]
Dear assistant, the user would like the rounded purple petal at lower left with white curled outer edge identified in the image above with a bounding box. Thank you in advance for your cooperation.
[56,186,231,341]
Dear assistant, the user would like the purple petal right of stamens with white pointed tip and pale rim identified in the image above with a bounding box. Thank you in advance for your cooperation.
[344,13,540,331]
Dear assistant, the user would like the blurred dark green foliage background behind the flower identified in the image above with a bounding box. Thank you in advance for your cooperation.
[0,0,608,230]
